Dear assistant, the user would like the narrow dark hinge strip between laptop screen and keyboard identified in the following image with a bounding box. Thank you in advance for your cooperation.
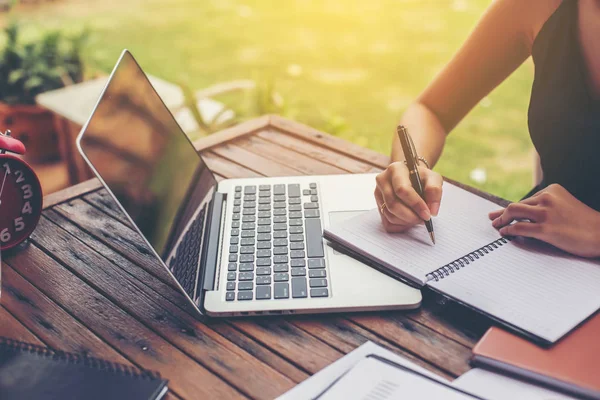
[201,192,226,290]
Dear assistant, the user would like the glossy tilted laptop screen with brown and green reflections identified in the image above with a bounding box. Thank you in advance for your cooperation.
[79,51,216,290]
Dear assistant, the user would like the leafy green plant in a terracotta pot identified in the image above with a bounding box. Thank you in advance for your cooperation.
[0,23,88,162]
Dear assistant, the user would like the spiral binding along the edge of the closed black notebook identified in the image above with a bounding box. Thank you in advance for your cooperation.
[0,337,160,380]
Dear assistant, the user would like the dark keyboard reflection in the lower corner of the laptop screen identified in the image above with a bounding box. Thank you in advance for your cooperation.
[169,204,207,297]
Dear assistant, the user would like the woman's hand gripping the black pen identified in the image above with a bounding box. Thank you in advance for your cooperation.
[375,162,443,233]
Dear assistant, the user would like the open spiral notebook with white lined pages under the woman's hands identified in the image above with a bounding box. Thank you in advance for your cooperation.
[324,182,600,345]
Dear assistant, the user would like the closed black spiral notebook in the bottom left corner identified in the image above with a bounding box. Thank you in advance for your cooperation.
[0,338,168,400]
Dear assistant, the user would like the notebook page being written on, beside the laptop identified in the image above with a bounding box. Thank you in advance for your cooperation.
[326,182,500,285]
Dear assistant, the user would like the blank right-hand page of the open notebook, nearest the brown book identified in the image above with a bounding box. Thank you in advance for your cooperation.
[428,239,600,342]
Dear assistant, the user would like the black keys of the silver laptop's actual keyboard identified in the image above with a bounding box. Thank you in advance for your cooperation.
[225,183,329,301]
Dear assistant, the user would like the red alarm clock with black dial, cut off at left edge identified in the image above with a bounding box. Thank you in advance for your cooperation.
[0,131,43,250]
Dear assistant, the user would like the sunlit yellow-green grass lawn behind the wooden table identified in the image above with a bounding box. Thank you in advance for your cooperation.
[7,0,533,200]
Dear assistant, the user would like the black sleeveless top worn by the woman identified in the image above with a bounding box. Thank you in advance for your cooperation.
[528,0,600,211]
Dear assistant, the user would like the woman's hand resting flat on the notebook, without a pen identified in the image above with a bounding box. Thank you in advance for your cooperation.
[489,184,600,258]
